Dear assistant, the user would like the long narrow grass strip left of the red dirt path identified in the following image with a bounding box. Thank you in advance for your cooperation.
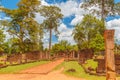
[0,61,49,74]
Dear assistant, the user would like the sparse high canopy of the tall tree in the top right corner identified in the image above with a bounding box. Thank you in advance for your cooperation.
[81,0,120,20]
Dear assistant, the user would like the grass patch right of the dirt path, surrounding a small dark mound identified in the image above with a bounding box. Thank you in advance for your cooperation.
[54,61,105,80]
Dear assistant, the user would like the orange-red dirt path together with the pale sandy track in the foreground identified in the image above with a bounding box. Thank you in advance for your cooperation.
[0,59,84,80]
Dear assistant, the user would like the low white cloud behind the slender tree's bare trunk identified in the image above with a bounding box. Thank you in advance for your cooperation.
[43,23,75,48]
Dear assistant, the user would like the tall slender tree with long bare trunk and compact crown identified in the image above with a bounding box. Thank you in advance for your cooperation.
[40,6,63,50]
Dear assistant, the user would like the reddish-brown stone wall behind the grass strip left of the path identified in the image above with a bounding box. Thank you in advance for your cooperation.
[6,51,50,64]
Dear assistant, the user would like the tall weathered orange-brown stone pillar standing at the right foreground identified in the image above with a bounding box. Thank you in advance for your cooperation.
[104,30,116,80]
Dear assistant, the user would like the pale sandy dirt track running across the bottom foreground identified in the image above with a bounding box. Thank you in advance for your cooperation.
[0,69,84,80]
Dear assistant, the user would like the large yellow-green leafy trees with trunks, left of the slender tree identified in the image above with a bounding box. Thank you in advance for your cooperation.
[1,0,42,52]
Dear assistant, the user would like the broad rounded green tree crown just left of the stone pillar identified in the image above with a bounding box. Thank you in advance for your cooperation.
[73,15,105,50]
